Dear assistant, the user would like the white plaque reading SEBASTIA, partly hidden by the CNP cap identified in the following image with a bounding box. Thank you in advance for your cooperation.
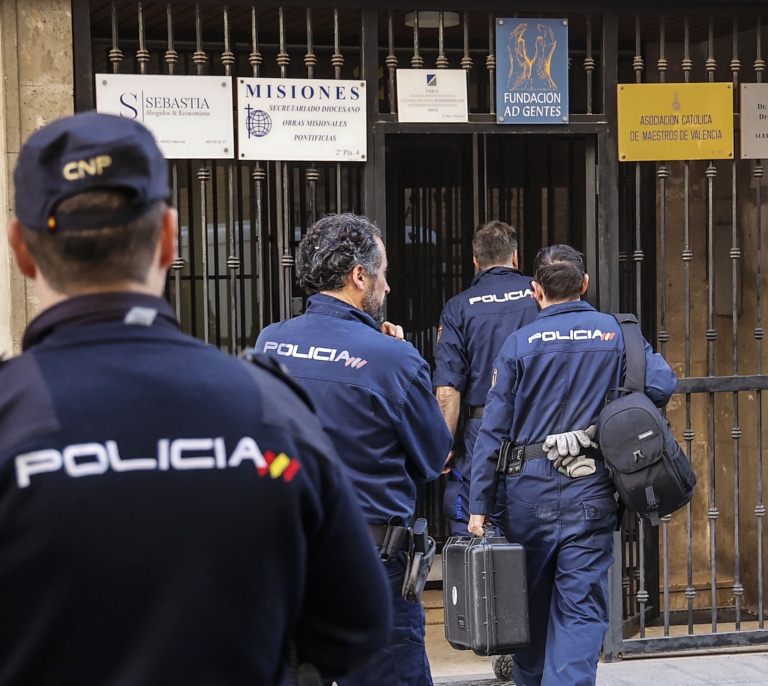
[96,74,235,159]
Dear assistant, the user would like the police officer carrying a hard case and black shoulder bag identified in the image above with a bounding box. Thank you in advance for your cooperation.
[469,245,675,686]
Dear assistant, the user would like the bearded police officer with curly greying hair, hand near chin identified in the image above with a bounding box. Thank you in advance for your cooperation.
[256,214,451,686]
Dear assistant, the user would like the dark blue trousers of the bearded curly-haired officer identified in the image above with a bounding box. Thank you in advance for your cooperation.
[336,553,432,686]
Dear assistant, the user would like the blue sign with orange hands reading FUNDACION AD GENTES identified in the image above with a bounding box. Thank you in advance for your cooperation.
[496,18,568,124]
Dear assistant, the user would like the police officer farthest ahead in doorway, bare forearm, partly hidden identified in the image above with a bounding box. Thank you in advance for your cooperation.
[432,221,536,536]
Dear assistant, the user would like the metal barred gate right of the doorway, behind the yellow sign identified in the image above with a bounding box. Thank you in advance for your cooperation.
[606,16,768,657]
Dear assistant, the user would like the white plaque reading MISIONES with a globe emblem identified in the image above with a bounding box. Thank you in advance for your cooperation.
[237,78,366,162]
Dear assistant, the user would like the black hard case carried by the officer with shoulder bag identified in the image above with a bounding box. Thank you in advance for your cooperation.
[443,536,529,655]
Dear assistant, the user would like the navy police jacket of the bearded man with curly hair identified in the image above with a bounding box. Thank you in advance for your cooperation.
[256,293,452,525]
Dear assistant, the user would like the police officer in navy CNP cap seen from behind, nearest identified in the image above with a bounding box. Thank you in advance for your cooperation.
[0,112,391,686]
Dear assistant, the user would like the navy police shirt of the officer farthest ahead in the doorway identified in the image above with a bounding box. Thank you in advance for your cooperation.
[432,267,536,405]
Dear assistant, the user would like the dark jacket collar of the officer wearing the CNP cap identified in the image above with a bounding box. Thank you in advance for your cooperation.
[22,292,179,350]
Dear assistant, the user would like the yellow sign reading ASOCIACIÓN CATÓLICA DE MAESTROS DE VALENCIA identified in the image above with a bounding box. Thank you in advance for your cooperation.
[618,83,733,162]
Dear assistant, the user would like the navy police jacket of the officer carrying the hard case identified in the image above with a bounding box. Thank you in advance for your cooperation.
[469,300,676,514]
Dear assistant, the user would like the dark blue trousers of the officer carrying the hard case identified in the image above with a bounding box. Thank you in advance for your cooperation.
[506,457,617,686]
